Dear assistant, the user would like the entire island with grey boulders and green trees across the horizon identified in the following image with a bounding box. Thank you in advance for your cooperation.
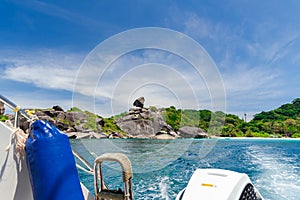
[0,97,300,139]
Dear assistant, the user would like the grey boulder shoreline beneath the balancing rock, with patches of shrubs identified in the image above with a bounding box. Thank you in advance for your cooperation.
[10,106,208,139]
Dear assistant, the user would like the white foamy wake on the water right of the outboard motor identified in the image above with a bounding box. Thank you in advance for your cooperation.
[247,145,300,200]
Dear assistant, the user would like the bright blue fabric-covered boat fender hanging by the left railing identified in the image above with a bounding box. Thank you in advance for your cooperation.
[25,120,84,200]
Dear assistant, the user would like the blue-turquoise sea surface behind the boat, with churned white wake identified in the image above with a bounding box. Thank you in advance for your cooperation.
[71,139,300,200]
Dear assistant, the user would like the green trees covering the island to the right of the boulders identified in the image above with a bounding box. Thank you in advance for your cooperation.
[163,98,300,138]
